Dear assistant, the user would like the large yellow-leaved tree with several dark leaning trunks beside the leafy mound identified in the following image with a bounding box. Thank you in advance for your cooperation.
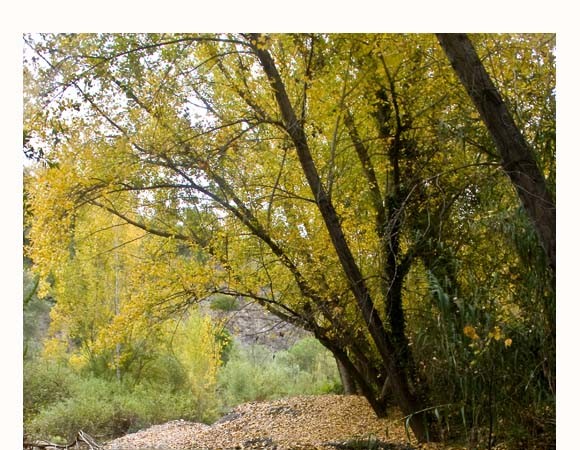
[25,34,556,441]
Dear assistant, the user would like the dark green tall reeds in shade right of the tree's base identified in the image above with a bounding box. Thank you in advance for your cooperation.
[413,268,555,448]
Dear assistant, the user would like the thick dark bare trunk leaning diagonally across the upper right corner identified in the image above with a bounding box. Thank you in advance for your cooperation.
[437,33,556,272]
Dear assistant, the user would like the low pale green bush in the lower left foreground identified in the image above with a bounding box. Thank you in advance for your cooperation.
[25,364,217,442]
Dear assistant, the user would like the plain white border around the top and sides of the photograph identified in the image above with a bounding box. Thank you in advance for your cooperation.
[0,0,580,448]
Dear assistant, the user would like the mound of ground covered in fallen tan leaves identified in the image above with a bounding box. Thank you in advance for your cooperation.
[105,395,436,450]
